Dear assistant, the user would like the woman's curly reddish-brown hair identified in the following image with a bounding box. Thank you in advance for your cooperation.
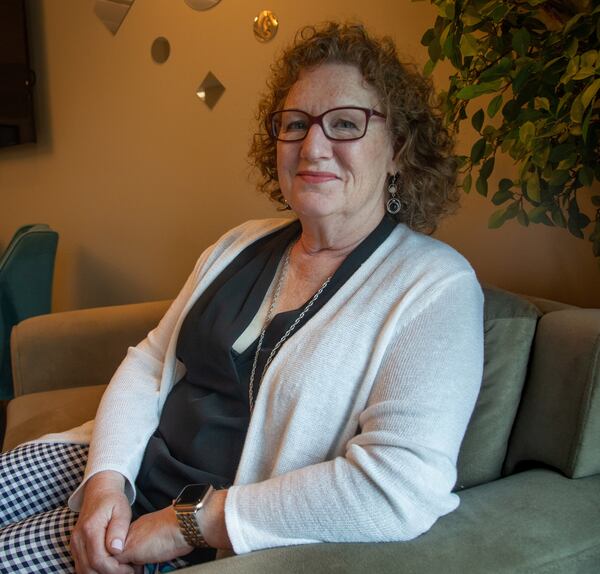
[248,22,458,233]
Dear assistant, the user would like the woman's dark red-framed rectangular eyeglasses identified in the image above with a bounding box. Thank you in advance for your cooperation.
[269,106,385,142]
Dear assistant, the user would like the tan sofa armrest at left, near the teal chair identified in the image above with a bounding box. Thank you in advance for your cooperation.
[11,301,170,396]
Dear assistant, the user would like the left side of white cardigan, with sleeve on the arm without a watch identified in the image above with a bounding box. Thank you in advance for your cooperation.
[69,219,290,511]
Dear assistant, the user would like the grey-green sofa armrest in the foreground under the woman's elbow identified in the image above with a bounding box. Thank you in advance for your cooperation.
[181,470,600,574]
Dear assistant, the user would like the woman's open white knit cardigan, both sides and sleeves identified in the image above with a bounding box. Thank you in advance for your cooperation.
[70,219,483,553]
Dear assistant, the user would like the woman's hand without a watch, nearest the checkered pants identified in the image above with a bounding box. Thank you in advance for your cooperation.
[71,471,133,574]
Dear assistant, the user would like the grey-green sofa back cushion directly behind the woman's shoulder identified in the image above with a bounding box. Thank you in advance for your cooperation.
[456,287,540,490]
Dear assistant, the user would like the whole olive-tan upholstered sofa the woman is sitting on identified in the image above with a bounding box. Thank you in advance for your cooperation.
[3,287,600,574]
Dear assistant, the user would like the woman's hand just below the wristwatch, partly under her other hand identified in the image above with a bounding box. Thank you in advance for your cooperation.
[116,506,193,564]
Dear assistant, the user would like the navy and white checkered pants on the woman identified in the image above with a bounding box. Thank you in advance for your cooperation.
[0,443,186,574]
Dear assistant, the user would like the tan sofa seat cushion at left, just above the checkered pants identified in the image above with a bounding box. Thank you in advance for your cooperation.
[2,385,106,451]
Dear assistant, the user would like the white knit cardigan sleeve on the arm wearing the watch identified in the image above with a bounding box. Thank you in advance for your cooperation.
[225,272,483,553]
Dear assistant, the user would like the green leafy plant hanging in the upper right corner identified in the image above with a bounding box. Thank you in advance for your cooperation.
[421,0,600,257]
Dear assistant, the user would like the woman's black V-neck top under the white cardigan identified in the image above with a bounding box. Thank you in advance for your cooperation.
[134,217,395,515]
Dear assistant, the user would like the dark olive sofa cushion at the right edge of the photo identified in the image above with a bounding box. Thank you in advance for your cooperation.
[505,308,600,478]
